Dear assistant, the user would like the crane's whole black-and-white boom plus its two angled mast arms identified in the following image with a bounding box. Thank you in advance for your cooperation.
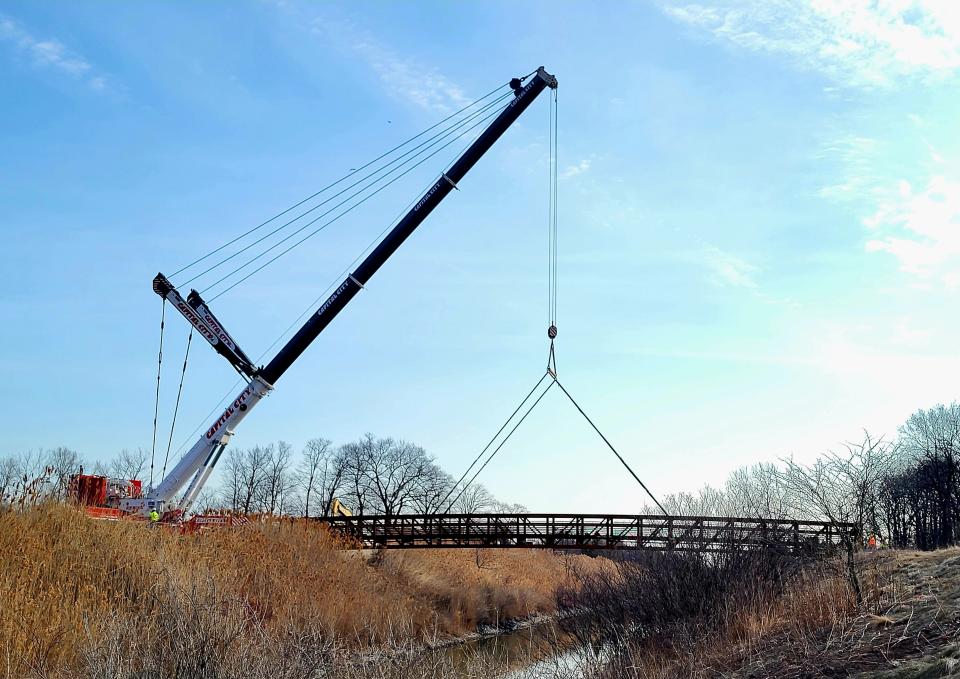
[119,66,557,520]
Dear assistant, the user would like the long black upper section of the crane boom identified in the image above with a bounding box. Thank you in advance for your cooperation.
[260,66,557,384]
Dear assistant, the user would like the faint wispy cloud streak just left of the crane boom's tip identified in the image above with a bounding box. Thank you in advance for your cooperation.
[311,17,470,113]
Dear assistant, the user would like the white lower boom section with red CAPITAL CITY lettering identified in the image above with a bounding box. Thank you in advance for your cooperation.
[121,377,273,514]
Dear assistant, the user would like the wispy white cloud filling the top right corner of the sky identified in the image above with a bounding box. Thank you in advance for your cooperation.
[664,0,960,88]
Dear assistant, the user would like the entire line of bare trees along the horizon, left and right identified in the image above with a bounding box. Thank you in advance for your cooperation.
[0,403,960,549]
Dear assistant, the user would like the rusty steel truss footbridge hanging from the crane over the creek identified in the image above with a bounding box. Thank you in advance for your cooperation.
[318,514,858,554]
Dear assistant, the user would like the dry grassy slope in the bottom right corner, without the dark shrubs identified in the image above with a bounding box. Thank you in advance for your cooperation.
[587,549,960,679]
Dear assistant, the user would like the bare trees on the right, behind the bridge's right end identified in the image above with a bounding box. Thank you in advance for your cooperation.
[644,403,960,550]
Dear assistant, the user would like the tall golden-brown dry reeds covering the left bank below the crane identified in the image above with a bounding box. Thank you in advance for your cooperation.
[0,505,589,677]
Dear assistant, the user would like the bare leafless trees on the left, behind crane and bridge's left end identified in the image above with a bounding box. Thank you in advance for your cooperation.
[0,434,526,517]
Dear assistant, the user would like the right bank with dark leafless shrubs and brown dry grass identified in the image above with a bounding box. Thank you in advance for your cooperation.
[556,549,960,679]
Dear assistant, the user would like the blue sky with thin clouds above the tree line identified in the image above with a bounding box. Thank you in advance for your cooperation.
[0,0,960,511]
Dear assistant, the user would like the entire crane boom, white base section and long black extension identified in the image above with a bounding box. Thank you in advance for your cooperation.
[121,66,557,514]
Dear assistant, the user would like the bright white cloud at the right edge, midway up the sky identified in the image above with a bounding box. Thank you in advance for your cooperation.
[863,175,960,288]
